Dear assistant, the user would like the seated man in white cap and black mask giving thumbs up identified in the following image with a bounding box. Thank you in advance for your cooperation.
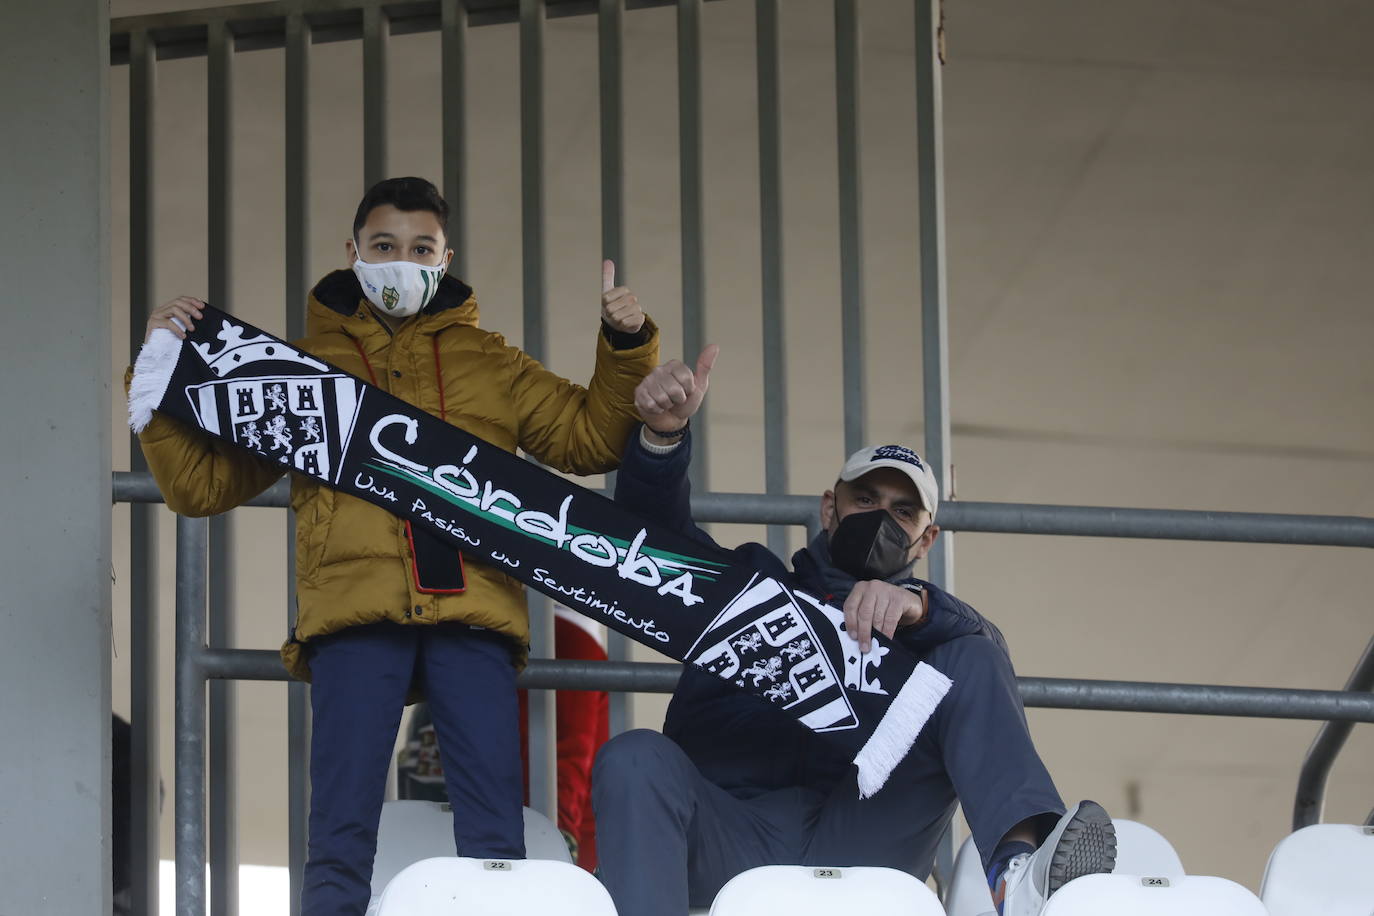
[592,346,1116,916]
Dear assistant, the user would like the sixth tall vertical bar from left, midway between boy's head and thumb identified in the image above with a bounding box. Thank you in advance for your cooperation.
[519,0,558,821]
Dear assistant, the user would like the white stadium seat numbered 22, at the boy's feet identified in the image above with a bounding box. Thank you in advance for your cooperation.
[376,858,616,916]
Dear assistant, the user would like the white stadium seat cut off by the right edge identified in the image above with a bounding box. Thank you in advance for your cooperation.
[1260,824,1374,916]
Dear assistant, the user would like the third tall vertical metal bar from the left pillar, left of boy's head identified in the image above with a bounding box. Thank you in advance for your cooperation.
[284,12,312,916]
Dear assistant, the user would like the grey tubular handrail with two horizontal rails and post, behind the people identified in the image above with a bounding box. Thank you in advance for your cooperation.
[113,472,1374,913]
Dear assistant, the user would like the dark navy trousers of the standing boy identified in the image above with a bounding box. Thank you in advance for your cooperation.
[301,623,525,916]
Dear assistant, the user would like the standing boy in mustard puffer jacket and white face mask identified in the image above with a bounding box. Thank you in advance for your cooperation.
[139,179,658,916]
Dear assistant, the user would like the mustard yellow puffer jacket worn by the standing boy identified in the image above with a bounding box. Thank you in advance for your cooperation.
[139,271,658,680]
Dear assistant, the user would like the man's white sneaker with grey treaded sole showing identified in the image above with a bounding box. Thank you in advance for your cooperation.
[993,802,1116,916]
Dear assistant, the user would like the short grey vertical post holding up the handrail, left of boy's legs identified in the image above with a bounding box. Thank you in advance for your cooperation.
[176,516,210,916]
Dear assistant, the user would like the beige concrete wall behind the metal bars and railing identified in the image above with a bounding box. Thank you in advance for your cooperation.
[111,0,1374,887]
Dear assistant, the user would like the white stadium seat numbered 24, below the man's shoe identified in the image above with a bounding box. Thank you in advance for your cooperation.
[1040,875,1269,916]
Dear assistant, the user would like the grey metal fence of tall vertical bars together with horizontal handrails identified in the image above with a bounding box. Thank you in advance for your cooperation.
[110,0,1374,916]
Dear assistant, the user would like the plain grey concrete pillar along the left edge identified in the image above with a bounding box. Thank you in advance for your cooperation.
[0,0,114,916]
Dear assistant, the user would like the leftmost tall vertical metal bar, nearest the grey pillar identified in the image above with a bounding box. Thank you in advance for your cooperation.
[128,32,159,913]
